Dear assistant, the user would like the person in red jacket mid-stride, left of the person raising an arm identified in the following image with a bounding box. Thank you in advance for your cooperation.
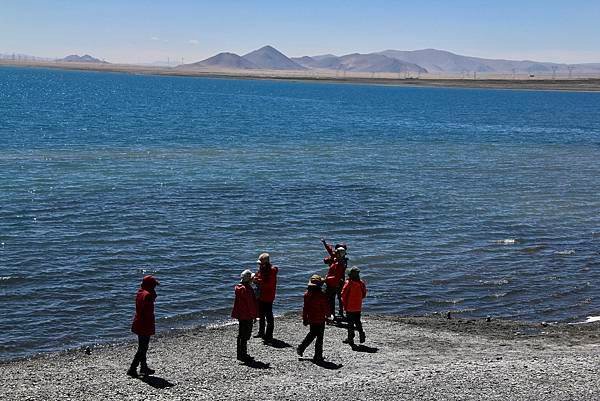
[296,274,329,362]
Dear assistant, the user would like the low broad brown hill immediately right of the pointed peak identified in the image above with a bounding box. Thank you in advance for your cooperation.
[294,53,427,73]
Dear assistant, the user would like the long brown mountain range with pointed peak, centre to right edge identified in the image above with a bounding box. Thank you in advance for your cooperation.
[177,46,600,74]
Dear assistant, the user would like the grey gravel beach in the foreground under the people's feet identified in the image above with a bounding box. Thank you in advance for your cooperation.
[0,315,600,400]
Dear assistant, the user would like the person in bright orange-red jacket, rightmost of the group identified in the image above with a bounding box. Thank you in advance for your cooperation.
[342,266,367,347]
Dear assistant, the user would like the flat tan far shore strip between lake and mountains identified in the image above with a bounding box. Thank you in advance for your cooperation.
[0,60,600,93]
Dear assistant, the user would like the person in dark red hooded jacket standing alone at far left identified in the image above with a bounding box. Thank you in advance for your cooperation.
[127,275,160,377]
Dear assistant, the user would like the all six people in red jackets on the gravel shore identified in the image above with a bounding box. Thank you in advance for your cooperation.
[127,239,367,377]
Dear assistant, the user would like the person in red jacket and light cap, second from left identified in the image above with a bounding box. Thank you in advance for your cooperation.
[231,270,258,362]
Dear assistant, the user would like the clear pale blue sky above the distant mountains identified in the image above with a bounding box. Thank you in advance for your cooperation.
[0,0,600,63]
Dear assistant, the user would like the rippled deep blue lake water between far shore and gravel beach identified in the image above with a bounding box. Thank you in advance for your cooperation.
[0,68,600,359]
